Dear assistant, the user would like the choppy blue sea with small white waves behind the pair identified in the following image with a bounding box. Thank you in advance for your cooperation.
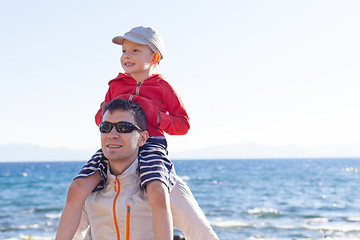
[0,159,360,240]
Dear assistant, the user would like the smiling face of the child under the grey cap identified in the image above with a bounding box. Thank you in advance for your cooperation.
[121,40,155,75]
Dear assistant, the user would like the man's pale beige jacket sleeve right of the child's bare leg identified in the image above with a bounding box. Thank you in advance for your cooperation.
[170,177,219,240]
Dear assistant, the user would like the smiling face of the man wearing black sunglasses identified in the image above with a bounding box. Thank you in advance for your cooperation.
[101,110,146,163]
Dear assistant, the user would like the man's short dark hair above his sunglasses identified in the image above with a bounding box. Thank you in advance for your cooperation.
[102,98,146,130]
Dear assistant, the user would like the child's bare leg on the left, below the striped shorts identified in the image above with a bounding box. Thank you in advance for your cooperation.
[56,172,102,240]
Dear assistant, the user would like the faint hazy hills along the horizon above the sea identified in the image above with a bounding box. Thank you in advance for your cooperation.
[0,144,360,162]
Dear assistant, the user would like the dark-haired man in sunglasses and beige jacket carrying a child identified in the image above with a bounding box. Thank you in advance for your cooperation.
[74,99,218,240]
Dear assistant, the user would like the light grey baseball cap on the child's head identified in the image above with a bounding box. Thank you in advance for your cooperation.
[112,26,165,59]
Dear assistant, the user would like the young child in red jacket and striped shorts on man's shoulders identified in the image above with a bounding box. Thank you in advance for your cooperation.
[56,27,190,240]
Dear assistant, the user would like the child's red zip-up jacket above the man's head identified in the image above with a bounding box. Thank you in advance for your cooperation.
[95,73,190,136]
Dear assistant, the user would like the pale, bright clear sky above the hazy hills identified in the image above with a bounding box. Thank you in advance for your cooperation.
[0,0,360,157]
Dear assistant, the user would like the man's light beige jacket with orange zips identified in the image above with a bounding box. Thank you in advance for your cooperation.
[73,159,218,240]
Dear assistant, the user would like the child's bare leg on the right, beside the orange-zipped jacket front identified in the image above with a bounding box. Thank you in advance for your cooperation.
[146,181,173,240]
